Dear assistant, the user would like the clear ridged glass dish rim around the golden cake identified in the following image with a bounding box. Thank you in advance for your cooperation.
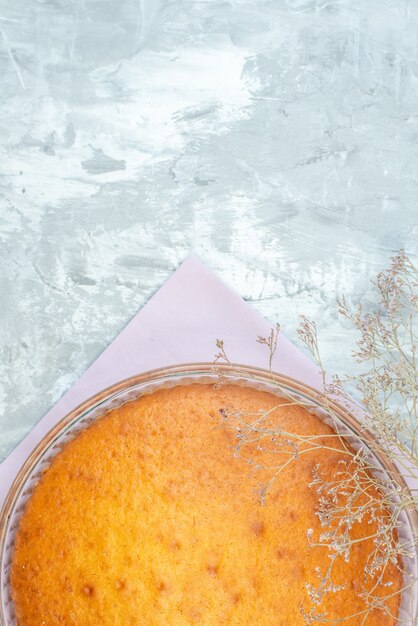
[0,363,418,626]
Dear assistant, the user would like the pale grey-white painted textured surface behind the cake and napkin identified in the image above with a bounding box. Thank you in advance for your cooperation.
[0,0,418,458]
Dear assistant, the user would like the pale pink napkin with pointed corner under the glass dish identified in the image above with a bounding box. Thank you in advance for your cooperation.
[0,255,320,507]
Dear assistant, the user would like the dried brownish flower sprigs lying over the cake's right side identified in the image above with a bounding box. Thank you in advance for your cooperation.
[216,252,418,626]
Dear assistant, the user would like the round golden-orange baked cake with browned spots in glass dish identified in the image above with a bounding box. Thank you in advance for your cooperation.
[11,384,402,626]
